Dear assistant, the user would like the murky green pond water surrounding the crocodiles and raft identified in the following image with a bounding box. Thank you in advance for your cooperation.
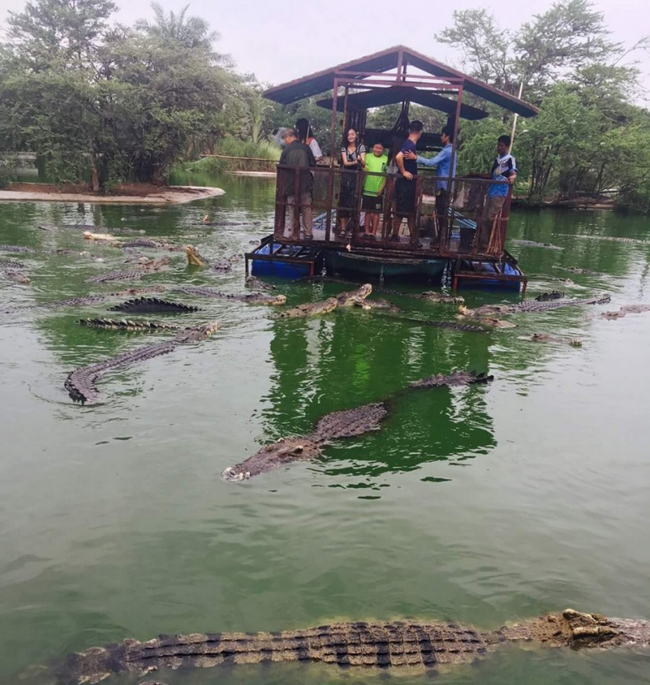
[0,179,650,685]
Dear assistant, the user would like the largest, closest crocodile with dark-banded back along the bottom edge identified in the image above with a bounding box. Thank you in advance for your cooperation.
[43,609,650,685]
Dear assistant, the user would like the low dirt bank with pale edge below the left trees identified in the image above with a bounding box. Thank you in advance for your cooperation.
[0,183,225,205]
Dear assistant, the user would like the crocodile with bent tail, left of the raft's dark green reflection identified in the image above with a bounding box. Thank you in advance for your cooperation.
[64,321,220,404]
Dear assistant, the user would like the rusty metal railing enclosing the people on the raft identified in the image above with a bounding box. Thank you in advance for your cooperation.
[274,165,512,260]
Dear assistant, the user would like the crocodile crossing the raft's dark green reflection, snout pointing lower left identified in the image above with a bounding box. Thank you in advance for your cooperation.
[221,371,492,481]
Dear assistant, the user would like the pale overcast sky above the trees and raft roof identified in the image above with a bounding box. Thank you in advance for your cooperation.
[0,0,650,97]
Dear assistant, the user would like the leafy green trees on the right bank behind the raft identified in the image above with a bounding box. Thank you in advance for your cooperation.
[439,0,650,211]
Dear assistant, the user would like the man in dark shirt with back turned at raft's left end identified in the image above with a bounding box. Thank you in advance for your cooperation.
[278,128,316,240]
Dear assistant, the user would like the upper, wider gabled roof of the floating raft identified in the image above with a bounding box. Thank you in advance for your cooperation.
[264,45,539,117]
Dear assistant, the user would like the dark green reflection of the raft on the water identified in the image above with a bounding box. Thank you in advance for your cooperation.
[263,296,496,487]
